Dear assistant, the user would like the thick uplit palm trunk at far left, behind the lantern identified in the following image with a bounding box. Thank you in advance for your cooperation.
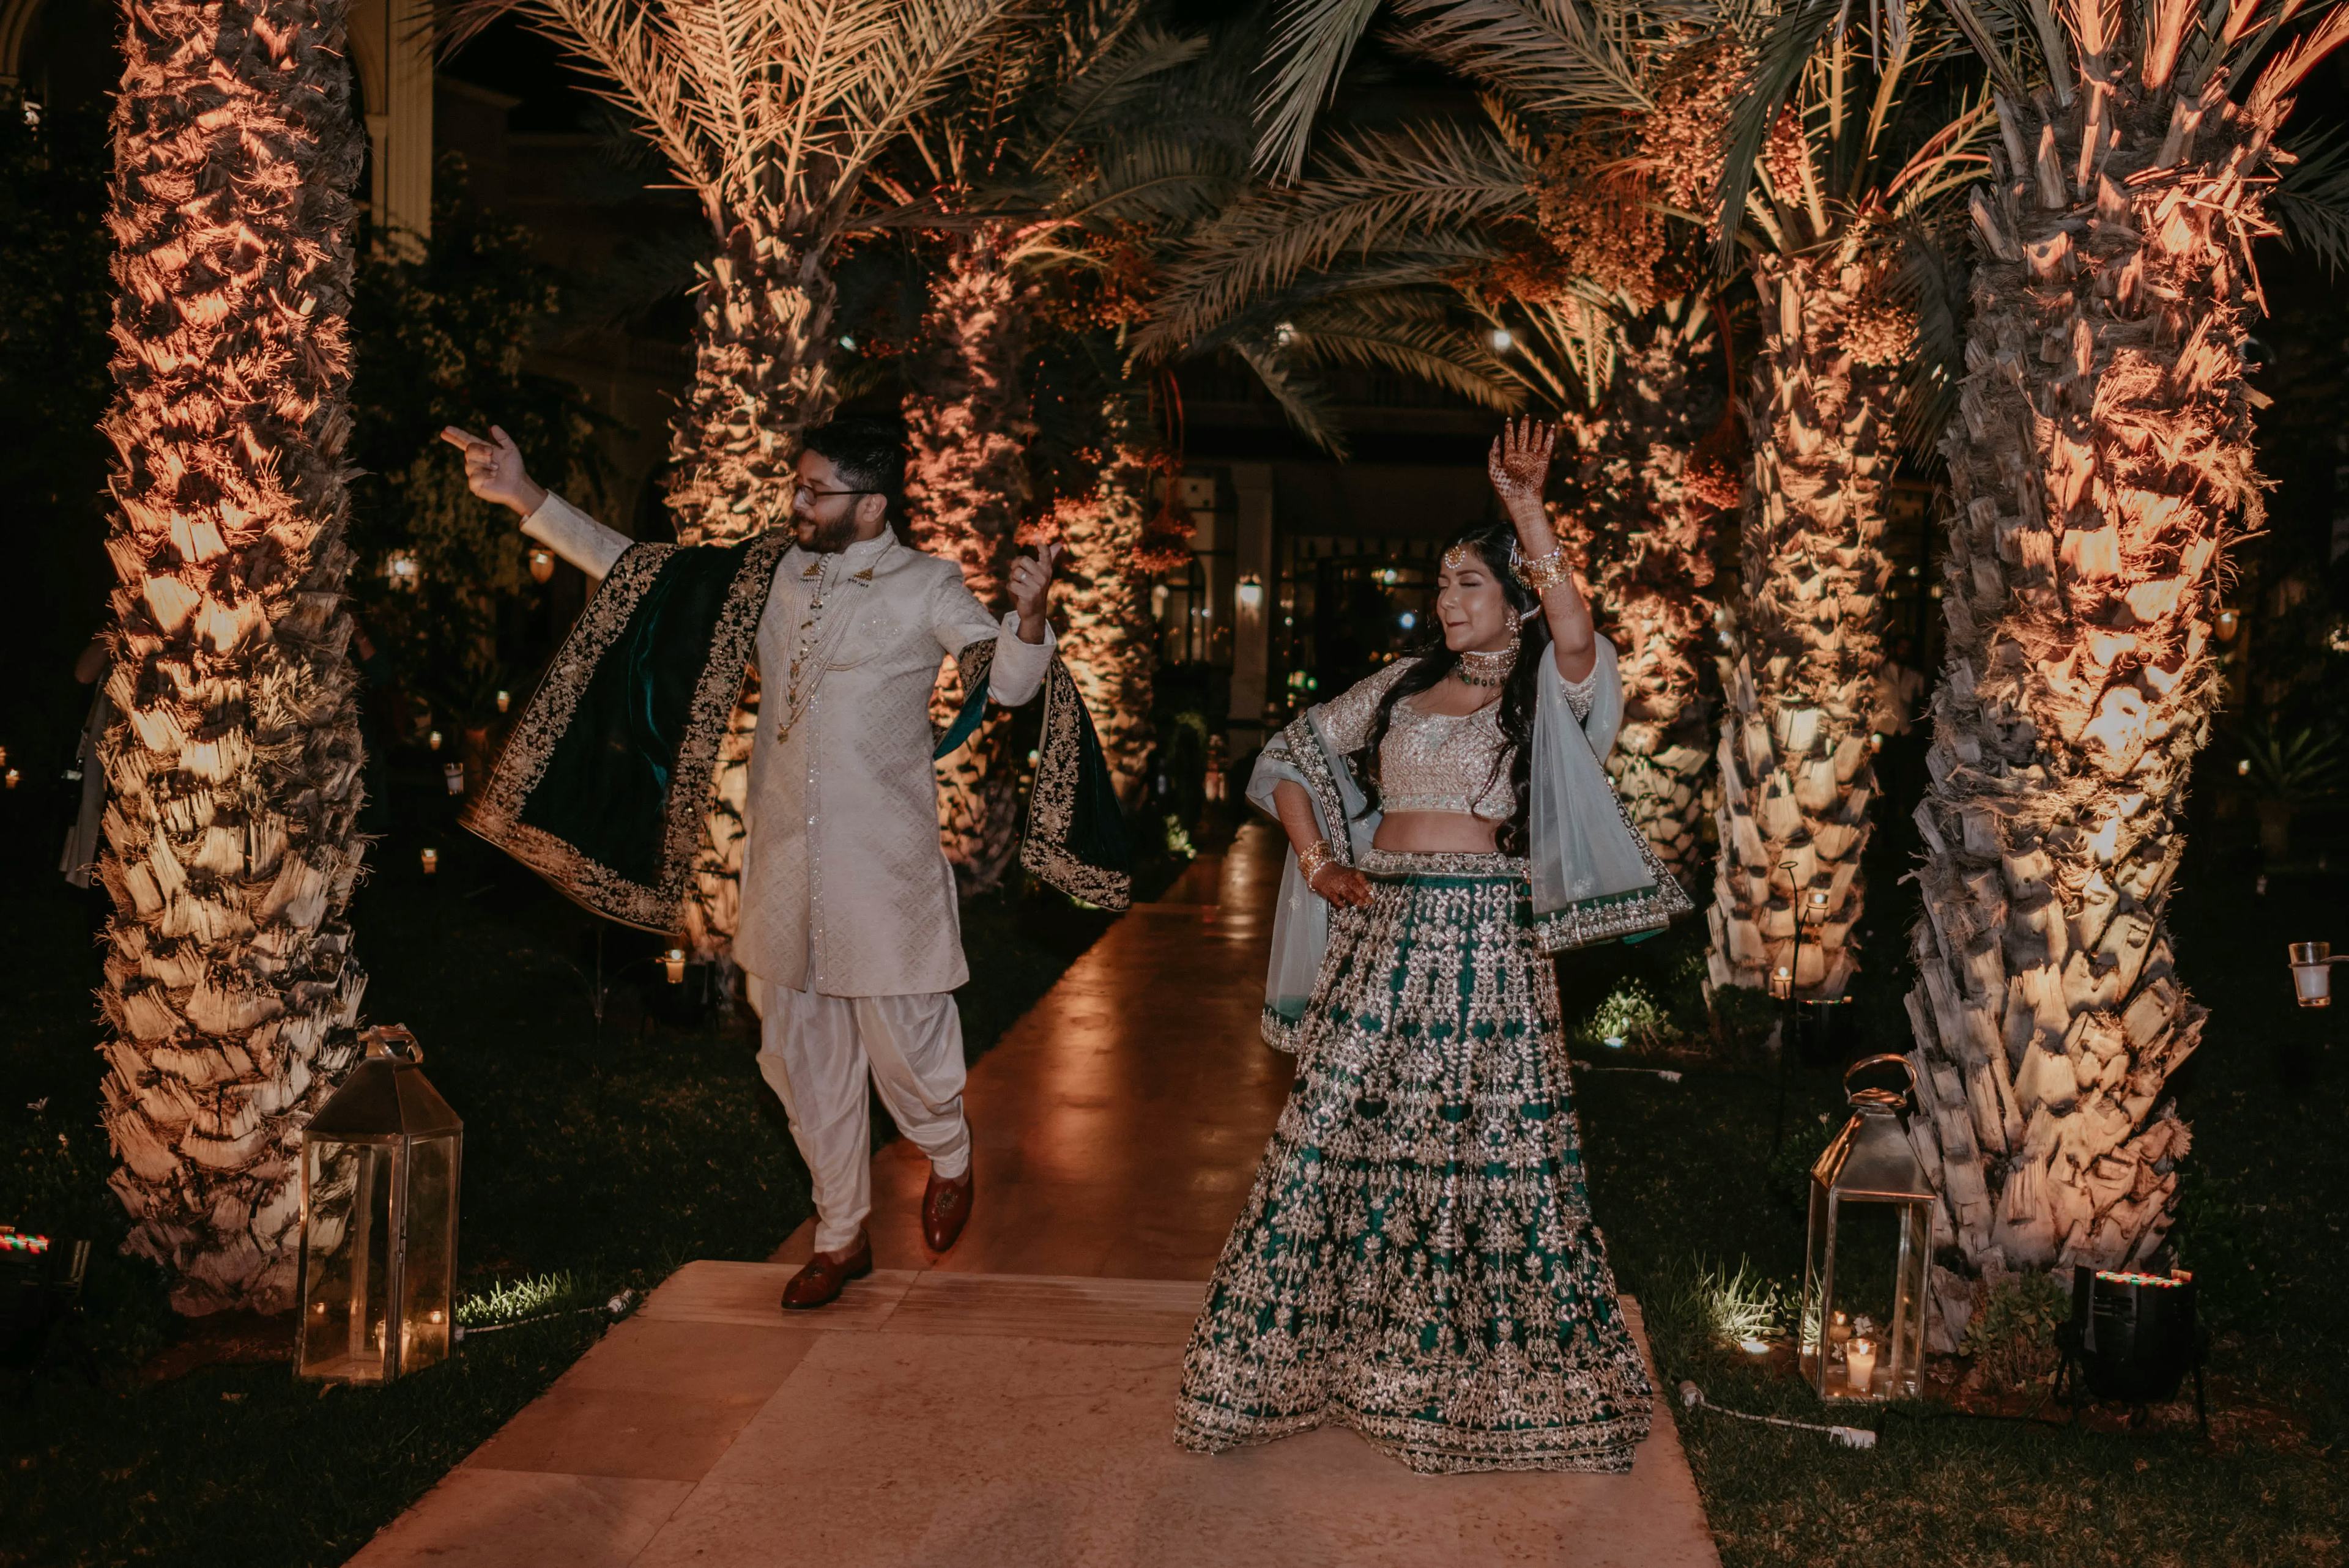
[98,0,366,1312]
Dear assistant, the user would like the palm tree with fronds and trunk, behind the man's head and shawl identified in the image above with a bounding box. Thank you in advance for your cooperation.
[451,0,1015,958]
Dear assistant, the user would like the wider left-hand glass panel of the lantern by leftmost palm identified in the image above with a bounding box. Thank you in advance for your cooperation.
[301,1139,395,1383]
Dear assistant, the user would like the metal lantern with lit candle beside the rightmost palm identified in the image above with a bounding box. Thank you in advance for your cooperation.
[1802,1056,1935,1401]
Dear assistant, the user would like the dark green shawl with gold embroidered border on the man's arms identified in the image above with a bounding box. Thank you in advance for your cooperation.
[462,533,1132,932]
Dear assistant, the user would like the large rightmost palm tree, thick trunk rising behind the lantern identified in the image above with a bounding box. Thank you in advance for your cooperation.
[1907,0,2349,1322]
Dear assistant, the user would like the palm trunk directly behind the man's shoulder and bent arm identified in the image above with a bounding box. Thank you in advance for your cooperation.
[904,225,1031,894]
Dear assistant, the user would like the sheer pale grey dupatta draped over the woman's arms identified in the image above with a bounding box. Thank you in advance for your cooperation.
[1247,638,1691,1052]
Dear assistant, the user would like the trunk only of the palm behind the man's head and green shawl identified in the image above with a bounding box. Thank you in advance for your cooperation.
[669,218,836,960]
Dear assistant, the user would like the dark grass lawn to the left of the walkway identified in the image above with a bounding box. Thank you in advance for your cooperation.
[0,769,1141,1568]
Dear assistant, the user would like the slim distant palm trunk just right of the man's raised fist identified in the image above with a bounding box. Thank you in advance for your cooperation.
[1055,438,1158,810]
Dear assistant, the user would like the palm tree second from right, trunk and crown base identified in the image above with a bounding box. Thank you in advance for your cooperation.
[1677,18,1987,997]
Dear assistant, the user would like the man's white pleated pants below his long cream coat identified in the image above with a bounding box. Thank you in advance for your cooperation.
[756,981,970,1251]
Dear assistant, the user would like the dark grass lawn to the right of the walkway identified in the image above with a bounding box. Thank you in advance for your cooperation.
[1562,737,2349,1568]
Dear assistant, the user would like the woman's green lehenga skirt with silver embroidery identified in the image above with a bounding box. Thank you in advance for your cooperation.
[1174,849,1652,1472]
